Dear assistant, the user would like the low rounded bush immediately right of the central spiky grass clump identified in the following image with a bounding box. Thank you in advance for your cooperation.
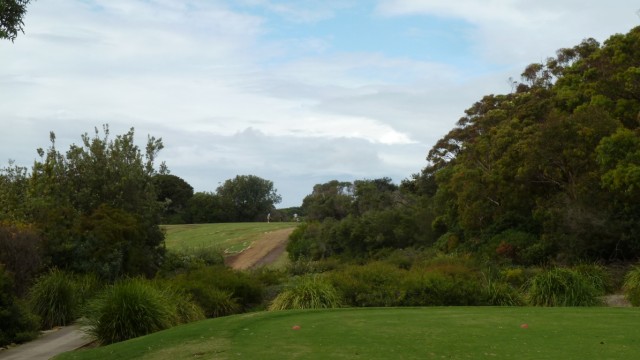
[329,262,408,307]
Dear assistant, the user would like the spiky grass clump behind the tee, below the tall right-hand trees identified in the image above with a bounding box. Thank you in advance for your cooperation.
[528,268,601,306]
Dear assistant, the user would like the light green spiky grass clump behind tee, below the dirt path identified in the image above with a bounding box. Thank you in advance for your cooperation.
[269,274,341,310]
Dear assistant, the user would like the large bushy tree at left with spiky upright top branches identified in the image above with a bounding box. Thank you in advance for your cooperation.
[26,125,164,278]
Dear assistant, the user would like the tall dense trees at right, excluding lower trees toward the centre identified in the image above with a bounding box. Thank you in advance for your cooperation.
[403,27,640,265]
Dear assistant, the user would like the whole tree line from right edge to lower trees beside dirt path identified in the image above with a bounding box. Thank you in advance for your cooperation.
[289,27,640,265]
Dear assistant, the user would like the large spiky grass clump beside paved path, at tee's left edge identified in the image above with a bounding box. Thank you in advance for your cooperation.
[84,278,178,344]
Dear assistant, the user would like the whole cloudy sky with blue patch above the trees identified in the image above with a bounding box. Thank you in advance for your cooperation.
[0,0,640,207]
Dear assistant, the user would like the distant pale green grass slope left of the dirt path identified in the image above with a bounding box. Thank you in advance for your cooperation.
[162,222,298,255]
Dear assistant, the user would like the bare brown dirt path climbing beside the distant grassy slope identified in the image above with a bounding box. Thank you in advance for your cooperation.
[225,228,293,270]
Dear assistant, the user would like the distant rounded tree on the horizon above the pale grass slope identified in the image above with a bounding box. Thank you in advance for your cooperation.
[217,175,282,221]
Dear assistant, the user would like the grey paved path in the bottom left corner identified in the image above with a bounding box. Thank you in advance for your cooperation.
[0,325,91,360]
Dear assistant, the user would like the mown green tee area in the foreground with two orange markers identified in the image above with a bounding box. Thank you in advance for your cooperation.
[55,307,640,360]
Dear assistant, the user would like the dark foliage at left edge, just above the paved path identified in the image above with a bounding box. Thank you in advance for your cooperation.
[0,264,39,347]
